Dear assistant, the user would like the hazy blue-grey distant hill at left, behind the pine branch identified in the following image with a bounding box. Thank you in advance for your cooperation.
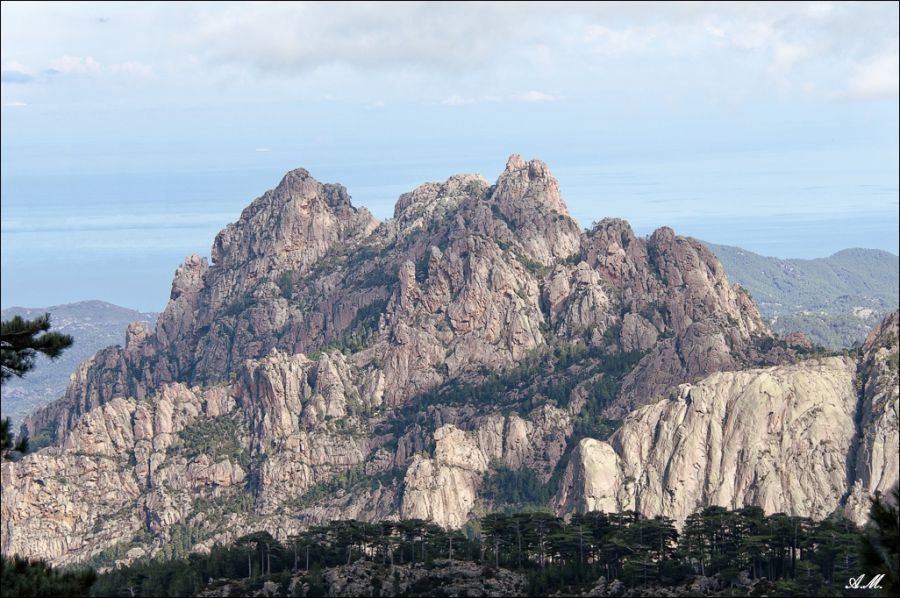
[0,301,158,426]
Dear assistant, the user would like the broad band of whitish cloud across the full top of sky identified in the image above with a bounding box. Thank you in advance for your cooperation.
[3,2,898,106]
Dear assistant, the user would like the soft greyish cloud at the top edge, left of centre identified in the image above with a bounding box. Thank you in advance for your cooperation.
[190,2,518,74]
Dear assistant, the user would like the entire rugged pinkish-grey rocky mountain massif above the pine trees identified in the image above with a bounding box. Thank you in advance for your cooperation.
[0,156,896,564]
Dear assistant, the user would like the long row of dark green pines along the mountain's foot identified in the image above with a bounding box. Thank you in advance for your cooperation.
[92,506,880,596]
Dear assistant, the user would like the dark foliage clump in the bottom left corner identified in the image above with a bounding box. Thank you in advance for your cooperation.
[0,556,97,598]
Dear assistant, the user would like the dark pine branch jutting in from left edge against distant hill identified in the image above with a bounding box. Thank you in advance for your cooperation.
[0,314,73,384]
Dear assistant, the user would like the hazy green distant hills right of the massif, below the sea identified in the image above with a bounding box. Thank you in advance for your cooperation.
[706,243,900,349]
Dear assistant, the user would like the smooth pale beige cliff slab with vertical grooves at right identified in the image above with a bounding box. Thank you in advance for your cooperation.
[555,313,898,523]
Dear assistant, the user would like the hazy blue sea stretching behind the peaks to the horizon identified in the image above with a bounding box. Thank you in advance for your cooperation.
[0,152,900,312]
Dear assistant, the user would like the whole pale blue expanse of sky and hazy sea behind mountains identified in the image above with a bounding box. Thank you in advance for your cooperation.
[0,2,900,311]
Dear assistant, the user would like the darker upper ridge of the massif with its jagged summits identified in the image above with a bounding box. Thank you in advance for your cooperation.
[22,156,772,437]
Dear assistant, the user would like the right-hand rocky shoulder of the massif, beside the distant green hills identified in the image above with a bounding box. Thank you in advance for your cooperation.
[582,219,772,418]
